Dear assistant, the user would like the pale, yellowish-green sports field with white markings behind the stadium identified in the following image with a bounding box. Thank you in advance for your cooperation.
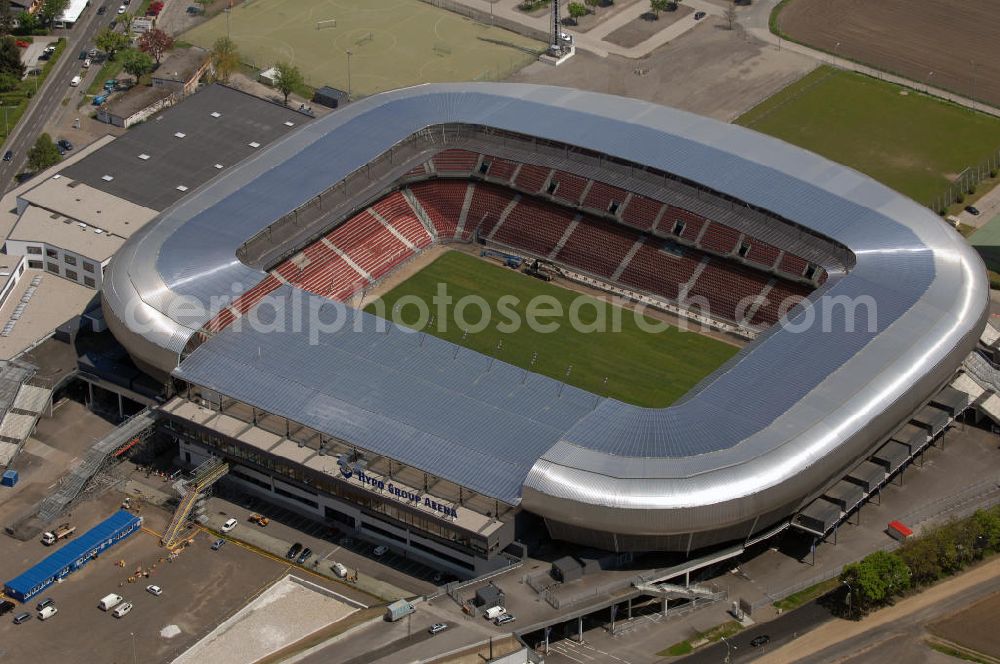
[183,0,545,97]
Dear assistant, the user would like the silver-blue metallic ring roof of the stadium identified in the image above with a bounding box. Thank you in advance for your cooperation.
[97,84,988,535]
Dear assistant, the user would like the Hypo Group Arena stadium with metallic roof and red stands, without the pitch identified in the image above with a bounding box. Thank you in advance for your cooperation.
[97,84,988,574]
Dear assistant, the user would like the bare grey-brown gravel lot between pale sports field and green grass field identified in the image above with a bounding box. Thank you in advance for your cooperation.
[508,18,816,122]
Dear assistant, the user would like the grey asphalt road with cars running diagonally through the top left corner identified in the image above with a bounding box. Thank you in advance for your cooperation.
[0,5,114,193]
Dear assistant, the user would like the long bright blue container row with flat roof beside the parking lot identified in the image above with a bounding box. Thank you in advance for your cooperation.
[4,510,142,602]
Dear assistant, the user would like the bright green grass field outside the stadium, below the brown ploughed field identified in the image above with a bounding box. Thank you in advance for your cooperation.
[736,67,1000,205]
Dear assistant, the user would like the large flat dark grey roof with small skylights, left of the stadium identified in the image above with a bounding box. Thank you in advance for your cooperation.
[62,84,312,211]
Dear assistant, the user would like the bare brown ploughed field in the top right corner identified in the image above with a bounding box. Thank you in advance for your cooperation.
[778,0,1000,106]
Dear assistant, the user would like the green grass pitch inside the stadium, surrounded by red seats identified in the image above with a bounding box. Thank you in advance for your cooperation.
[366,251,739,407]
